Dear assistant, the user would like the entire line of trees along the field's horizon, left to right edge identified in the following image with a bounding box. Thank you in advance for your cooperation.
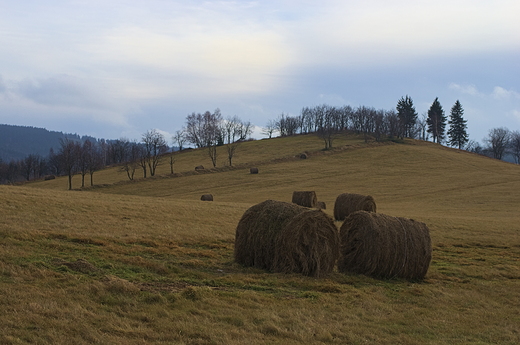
[0,95,520,189]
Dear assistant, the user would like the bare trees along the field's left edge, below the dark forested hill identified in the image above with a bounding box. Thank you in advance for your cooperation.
[0,109,253,189]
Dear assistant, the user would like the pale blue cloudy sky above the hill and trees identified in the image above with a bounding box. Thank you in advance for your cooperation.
[0,0,520,141]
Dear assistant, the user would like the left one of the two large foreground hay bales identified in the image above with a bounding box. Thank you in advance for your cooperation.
[234,200,339,277]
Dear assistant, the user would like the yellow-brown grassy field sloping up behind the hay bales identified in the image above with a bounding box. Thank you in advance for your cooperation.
[0,136,520,344]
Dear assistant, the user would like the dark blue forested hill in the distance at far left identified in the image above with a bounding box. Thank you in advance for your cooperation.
[0,124,97,162]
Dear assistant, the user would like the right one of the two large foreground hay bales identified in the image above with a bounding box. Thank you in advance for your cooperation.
[338,211,432,280]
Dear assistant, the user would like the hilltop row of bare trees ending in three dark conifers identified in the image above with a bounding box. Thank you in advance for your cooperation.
[263,96,468,149]
